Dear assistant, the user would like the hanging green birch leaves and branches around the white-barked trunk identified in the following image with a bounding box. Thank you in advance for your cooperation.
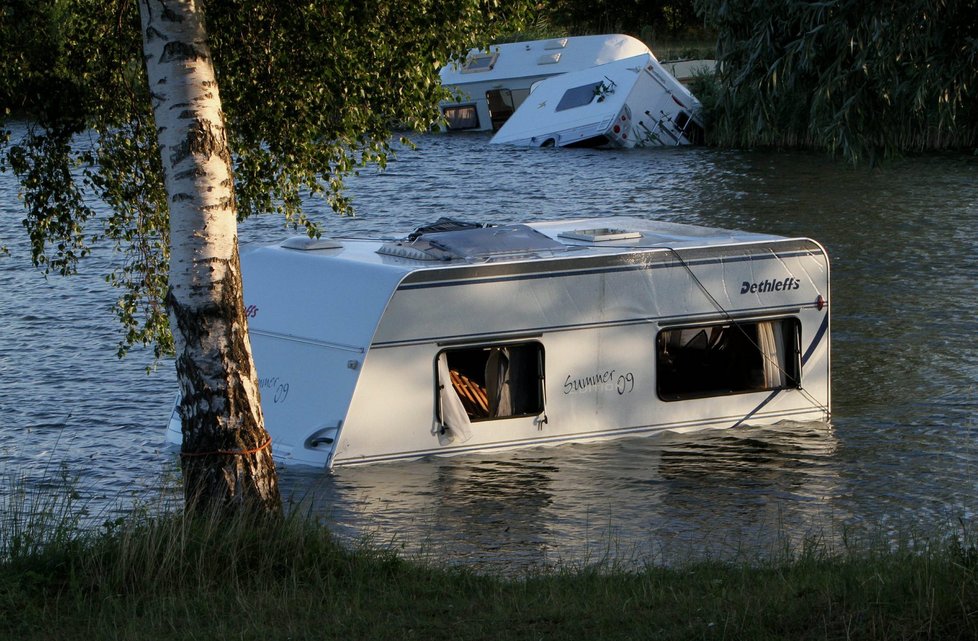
[0,0,529,355]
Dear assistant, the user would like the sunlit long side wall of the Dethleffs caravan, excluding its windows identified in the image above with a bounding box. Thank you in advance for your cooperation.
[334,241,829,465]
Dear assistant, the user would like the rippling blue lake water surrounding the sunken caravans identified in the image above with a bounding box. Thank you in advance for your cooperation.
[0,135,978,571]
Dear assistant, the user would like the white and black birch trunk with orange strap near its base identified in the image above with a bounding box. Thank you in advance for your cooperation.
[139,0,281,514]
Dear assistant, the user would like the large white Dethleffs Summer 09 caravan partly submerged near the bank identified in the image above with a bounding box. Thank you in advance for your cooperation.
[168,217,830,468]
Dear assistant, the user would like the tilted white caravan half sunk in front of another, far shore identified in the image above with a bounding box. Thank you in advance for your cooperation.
[490,53,703,148]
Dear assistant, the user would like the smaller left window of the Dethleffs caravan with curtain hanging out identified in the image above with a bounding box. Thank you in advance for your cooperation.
[438,342,543,421]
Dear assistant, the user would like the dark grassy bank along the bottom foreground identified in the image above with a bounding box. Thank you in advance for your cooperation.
[0,484,978,641]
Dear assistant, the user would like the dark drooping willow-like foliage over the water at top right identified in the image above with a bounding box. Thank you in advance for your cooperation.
[697,0,978,162]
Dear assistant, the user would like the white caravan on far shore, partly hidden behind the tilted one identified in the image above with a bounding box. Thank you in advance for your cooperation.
[441,34,650,131]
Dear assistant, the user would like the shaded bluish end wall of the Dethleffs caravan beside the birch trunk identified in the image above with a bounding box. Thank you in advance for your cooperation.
[234,247,405,466]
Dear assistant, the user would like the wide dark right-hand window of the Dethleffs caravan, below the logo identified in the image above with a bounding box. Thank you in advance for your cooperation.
[656,318,801,401]
